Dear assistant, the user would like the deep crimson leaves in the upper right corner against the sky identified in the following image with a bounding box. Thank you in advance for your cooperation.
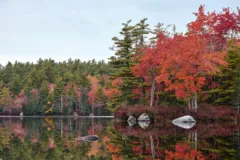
[188,6,240,52]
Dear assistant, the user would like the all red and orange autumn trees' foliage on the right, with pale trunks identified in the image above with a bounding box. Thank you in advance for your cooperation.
[132,6,240,109]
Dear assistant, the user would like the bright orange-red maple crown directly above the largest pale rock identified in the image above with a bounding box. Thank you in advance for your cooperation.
[156,35,226,98]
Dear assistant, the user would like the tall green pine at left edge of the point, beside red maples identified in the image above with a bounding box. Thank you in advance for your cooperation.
[109,20,135,107]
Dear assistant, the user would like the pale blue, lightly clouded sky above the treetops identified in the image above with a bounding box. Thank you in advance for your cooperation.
[0,0,240,65]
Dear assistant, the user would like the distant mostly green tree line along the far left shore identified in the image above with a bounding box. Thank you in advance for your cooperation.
[0,59,111,115]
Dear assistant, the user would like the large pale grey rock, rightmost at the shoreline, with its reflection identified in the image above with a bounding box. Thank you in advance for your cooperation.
[172,115,196,129]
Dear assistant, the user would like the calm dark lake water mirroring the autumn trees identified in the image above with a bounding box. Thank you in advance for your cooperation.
[0,118,240,160]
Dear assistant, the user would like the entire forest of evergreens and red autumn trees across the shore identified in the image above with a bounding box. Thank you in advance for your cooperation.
[0,5,240,115]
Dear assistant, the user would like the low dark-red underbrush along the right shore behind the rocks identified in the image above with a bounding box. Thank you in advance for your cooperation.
[114,104,240,121]
